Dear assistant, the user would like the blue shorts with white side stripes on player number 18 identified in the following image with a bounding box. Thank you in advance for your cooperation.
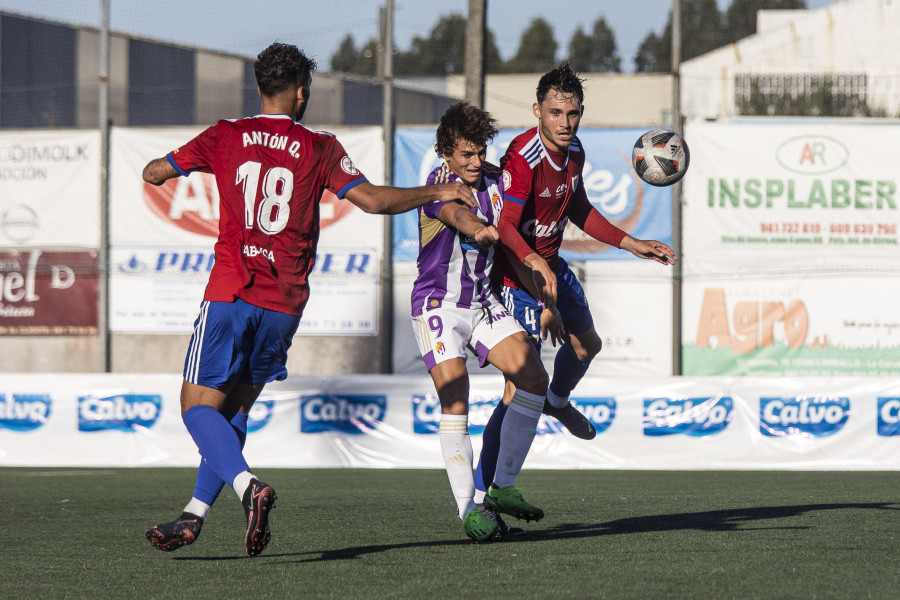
[184,299,300,389]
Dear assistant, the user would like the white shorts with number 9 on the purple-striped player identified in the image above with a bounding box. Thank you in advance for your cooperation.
[413,298,525,371]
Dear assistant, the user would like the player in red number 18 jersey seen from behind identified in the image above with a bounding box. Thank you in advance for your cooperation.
[143,43,476,556]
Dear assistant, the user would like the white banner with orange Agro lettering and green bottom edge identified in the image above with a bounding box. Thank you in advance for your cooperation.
[682,276,900,376]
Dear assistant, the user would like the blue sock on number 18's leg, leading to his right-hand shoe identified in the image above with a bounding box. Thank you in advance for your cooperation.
[182,406,250,485]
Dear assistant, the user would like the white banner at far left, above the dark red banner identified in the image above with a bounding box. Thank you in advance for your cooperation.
[0,130,100,249]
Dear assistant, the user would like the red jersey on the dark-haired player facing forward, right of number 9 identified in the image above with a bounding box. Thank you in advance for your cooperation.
[498,127,625,288]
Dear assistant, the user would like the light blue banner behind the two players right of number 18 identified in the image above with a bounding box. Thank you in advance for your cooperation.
[393,129,672,262]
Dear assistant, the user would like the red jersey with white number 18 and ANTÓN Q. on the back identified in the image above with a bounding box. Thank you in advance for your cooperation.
[168,115,366,316]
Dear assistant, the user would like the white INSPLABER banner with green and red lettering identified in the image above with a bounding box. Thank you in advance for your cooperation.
[684,121,900,276]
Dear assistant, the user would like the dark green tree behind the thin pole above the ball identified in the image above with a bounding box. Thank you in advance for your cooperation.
[634,0,723,73]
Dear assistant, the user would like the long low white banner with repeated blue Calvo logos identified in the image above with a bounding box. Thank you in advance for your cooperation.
[0,374,900,470]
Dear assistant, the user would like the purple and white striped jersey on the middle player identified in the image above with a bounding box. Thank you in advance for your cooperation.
[412,163,503,317]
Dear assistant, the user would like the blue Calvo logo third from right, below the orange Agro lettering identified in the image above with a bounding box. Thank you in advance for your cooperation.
[644,396,734,437]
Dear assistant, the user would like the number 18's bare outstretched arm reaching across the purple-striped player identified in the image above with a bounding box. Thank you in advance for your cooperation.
[345,181,478,215]
